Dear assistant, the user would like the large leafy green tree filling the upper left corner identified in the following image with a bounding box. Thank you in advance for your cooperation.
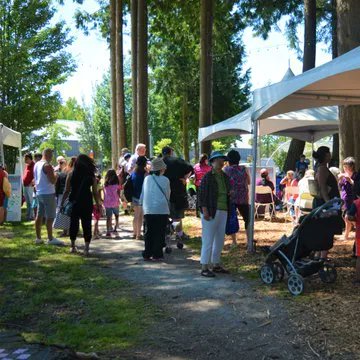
[0,0,75,145]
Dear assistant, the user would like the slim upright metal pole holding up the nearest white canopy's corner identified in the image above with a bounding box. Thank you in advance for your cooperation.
[247,120,258,253]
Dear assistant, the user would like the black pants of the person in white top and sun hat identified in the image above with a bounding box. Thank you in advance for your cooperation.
[143,215,169,258]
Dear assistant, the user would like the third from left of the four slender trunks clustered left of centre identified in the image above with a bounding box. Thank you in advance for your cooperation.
[131,0,139,151]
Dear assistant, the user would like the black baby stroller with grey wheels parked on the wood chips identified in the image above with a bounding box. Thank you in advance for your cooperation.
[260,198,344,296]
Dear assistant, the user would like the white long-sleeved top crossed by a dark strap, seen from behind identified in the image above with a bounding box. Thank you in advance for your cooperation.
[140,175,170,215]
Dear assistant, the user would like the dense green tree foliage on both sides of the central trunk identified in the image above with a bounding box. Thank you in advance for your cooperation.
[149,0,249,158]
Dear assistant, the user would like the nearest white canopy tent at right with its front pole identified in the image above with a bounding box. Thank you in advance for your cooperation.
[198,47,360,252]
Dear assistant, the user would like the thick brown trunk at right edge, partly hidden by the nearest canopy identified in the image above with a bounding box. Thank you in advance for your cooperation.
[337,0,360,166]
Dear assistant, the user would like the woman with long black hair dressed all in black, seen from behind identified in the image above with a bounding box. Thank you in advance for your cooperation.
[63,154,100,256]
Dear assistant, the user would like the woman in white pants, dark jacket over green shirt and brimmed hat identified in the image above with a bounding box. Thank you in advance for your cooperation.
[198,151,230,277]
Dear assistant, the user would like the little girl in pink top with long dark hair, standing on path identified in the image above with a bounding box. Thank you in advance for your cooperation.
[104,169,120,237]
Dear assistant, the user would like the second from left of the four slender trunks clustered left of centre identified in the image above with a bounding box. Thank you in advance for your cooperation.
[116,0,127,153]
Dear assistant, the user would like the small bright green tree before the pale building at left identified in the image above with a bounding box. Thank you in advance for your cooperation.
[38,123,71,162]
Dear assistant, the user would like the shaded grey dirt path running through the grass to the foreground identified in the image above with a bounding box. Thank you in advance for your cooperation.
[92,226,325,360]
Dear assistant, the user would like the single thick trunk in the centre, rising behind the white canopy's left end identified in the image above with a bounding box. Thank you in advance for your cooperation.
[199,0,214,154]
